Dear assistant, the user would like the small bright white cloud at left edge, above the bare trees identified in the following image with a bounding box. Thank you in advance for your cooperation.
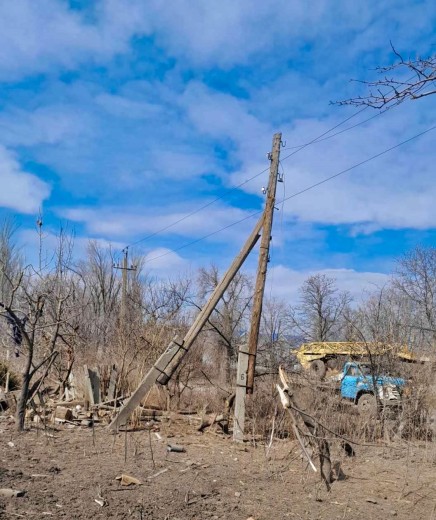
[0,145,51,213]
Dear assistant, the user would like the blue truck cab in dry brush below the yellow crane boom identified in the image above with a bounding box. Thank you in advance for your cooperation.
[335,361,406,415]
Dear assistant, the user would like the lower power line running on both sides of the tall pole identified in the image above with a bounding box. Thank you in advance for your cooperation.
[147,125,436,262]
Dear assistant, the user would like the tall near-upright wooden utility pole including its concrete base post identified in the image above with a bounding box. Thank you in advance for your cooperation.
[233,133,282,442]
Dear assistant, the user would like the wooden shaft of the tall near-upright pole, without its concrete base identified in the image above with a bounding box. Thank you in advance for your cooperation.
[246,133,282,394]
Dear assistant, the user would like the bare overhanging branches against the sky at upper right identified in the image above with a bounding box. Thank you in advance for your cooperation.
[338,43,436,109]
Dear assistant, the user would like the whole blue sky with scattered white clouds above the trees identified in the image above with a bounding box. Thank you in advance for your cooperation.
[0,0,436,299]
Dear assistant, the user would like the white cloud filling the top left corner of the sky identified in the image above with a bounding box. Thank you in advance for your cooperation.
[0,0,147,79]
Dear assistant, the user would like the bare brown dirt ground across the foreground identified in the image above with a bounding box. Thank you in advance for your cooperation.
[0,416,436,520]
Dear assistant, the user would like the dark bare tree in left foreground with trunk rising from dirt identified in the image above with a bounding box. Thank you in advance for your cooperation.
[0,232,82,430]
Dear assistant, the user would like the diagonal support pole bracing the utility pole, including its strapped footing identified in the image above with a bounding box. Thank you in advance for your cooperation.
[108,215,264,430]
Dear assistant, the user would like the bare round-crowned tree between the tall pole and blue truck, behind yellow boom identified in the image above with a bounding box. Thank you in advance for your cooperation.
[292,274,351,341]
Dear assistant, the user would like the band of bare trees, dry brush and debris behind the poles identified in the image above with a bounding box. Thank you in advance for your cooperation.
[0,218,436,518]
